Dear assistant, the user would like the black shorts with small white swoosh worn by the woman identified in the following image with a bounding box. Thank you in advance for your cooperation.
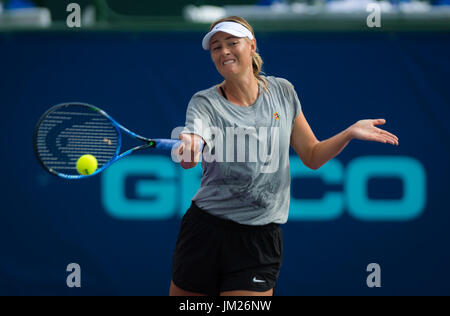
[172,203,283,296]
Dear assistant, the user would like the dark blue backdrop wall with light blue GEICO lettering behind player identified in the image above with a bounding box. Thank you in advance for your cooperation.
[0,32,450,295]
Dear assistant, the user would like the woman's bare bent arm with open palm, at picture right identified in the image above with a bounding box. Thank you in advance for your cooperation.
[291,112,398,170]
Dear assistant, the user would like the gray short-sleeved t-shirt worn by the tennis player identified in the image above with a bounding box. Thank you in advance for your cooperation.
[182,77,301,225]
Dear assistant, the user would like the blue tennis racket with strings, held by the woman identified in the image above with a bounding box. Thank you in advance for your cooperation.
[33,103,181,179]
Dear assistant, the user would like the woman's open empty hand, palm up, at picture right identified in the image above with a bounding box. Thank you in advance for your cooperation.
[349,119,398,146]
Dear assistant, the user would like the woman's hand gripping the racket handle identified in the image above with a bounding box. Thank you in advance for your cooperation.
[176,134,205,169]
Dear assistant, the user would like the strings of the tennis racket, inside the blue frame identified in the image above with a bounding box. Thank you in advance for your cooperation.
[36,104,119,175]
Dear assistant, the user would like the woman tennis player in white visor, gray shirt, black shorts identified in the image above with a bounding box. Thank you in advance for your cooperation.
[170,16,398,296]
